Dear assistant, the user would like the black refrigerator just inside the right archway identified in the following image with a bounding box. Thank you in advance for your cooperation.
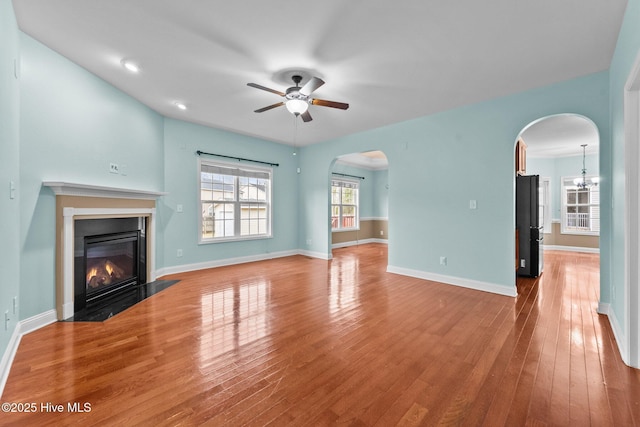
[516,175,544,277]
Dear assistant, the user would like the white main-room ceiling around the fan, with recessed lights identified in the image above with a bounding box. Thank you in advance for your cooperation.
[13,0,627,145]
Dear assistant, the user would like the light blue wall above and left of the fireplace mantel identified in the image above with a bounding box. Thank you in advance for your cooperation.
[19,33,164,319]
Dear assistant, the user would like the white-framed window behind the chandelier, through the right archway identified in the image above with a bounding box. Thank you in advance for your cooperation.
[562,177,600,236]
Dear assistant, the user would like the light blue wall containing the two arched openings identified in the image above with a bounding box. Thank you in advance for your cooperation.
[299,72,609,289]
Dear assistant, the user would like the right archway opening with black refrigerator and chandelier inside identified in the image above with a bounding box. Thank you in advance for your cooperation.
[515,114,600,277]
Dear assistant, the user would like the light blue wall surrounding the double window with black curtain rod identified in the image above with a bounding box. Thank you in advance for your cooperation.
[158,119,298,267]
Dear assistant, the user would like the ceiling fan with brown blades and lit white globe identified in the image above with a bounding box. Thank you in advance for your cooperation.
[247,75,349,122]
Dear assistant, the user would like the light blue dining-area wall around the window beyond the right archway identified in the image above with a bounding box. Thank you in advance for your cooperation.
[527,154,600,221]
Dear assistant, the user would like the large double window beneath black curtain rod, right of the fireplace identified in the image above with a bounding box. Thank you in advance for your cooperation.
[199,159,272,243]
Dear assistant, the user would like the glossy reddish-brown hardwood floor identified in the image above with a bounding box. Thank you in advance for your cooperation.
[0,244,640,426]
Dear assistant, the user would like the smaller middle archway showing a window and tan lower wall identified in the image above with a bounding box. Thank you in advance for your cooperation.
[329,150,389,258]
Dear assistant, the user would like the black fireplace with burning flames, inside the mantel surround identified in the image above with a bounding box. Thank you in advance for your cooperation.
[74,217,146,313]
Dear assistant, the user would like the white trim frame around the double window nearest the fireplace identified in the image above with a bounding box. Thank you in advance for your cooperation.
[196,157,273,245]
